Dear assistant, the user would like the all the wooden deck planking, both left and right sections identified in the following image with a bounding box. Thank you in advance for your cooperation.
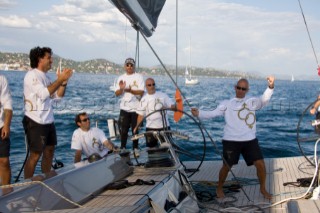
[37,157,320,213]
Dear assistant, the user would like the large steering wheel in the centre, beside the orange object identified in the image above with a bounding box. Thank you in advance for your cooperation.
[131,108,206,177]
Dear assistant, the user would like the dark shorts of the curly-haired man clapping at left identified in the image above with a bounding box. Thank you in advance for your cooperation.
[22,116,57,152]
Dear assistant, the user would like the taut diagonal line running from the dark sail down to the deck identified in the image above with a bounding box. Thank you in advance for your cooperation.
[141,33,252,202]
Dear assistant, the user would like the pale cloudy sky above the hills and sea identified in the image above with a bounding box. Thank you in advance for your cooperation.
[0,0,320,79]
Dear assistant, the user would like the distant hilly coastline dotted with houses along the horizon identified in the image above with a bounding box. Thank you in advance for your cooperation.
[0,52,261,79]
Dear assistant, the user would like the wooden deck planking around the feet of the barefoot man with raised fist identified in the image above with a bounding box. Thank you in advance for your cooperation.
[187,157,320,213]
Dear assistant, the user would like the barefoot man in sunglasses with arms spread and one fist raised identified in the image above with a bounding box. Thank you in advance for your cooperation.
[191,76,275,199]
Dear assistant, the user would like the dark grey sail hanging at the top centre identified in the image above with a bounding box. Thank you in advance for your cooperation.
[109,0,166,37]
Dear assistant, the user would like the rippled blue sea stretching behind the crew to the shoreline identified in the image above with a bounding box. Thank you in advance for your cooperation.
[0,71,320,181]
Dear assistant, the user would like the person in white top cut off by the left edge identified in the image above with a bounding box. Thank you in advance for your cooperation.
[0,75,12,186]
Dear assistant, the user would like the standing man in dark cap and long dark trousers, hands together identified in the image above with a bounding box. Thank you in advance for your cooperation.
[115,58,144,156]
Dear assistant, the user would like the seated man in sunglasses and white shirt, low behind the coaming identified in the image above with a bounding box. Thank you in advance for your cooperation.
[71,112,117,163]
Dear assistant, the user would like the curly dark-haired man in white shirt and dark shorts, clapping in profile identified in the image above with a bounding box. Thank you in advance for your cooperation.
[23,47,73,179]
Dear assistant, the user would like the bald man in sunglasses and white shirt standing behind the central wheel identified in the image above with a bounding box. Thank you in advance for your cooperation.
[135,78,175,148]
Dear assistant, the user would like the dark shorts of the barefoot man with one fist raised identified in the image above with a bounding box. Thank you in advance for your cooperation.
[222,138,263,167]
